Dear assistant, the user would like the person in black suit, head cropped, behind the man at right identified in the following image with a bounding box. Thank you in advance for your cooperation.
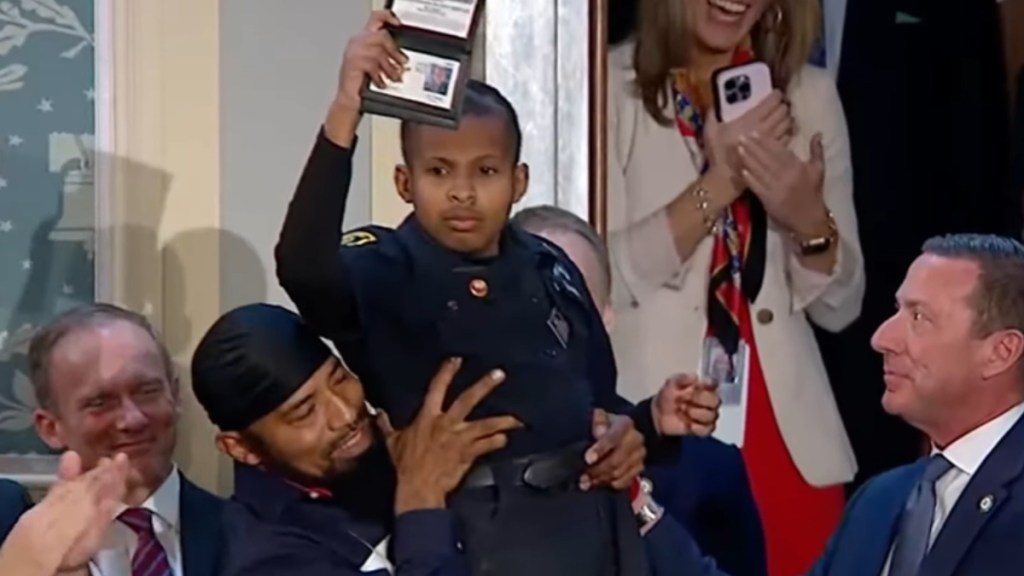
[817,0,1022,494]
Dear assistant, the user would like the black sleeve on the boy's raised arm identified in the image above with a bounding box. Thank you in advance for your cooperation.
[274,130,359,339]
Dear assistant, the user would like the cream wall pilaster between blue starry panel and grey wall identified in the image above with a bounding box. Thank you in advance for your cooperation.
[95,0,230,493]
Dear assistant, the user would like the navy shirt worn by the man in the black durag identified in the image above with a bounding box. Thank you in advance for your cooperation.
[220,464,470,576]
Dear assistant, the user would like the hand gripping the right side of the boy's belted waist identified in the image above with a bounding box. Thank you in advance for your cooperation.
[580,410,647,490]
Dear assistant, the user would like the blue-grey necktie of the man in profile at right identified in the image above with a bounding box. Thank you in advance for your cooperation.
[889,454,953,576]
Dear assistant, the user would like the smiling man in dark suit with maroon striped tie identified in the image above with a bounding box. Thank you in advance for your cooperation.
[14,303,222,576]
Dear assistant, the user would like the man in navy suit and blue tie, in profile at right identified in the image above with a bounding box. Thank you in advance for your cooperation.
[811,235,1024,576]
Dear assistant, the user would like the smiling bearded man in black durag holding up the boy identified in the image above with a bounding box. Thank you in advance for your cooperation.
[193,304,520,576]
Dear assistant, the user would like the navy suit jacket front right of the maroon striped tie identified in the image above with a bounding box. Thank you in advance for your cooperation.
[180,476,222,576]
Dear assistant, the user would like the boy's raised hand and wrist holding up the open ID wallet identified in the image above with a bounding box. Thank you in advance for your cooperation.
[324,10,409,148]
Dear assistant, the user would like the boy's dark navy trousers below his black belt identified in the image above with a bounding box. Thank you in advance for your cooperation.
[449,485,647,576]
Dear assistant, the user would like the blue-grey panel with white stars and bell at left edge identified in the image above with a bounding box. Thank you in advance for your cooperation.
[0,0,95,472]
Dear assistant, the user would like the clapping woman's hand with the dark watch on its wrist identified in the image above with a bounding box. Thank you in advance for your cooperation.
[738,132,828,236]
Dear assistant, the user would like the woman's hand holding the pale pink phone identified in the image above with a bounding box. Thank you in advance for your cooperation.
[705,90,794,188]
